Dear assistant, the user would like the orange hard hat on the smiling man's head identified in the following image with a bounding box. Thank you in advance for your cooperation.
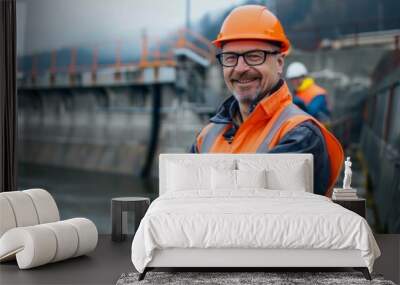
[213,5,290,54]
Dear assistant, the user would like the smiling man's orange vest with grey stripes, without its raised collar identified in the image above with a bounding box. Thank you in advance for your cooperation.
[198,103,344,197]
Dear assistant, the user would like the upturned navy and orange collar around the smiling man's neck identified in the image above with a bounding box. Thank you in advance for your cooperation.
[210,79,292,124]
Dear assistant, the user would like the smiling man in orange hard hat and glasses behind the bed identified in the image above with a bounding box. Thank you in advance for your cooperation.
[191,5,343,197]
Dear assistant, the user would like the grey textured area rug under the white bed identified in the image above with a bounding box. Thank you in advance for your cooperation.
[117,271,395,285]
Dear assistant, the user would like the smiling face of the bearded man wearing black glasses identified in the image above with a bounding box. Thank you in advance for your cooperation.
[222,40,284,106]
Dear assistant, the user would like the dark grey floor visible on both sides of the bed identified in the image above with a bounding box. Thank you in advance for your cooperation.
[0,235,400,285]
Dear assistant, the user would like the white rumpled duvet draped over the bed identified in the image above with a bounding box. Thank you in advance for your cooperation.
[132,189,380,272]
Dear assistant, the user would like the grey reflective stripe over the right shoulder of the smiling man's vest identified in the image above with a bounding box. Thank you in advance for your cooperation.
[257,104,307,153]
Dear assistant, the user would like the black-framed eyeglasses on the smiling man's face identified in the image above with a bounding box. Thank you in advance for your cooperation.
[216,50,280,67]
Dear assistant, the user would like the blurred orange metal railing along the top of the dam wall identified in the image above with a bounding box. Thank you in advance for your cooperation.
[18,29,215,81]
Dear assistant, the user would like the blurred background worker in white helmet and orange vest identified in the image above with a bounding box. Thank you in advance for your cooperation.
[286,61,330,124]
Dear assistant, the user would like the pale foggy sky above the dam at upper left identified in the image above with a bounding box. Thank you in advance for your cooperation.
[17,0,242,55]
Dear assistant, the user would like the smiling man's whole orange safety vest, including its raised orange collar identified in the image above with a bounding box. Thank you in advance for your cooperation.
[197,83,344,197]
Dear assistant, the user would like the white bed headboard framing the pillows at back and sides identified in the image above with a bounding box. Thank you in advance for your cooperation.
[159,153,314,195]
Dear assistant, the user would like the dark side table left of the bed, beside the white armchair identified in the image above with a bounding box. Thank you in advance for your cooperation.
[111,197,150,241]
